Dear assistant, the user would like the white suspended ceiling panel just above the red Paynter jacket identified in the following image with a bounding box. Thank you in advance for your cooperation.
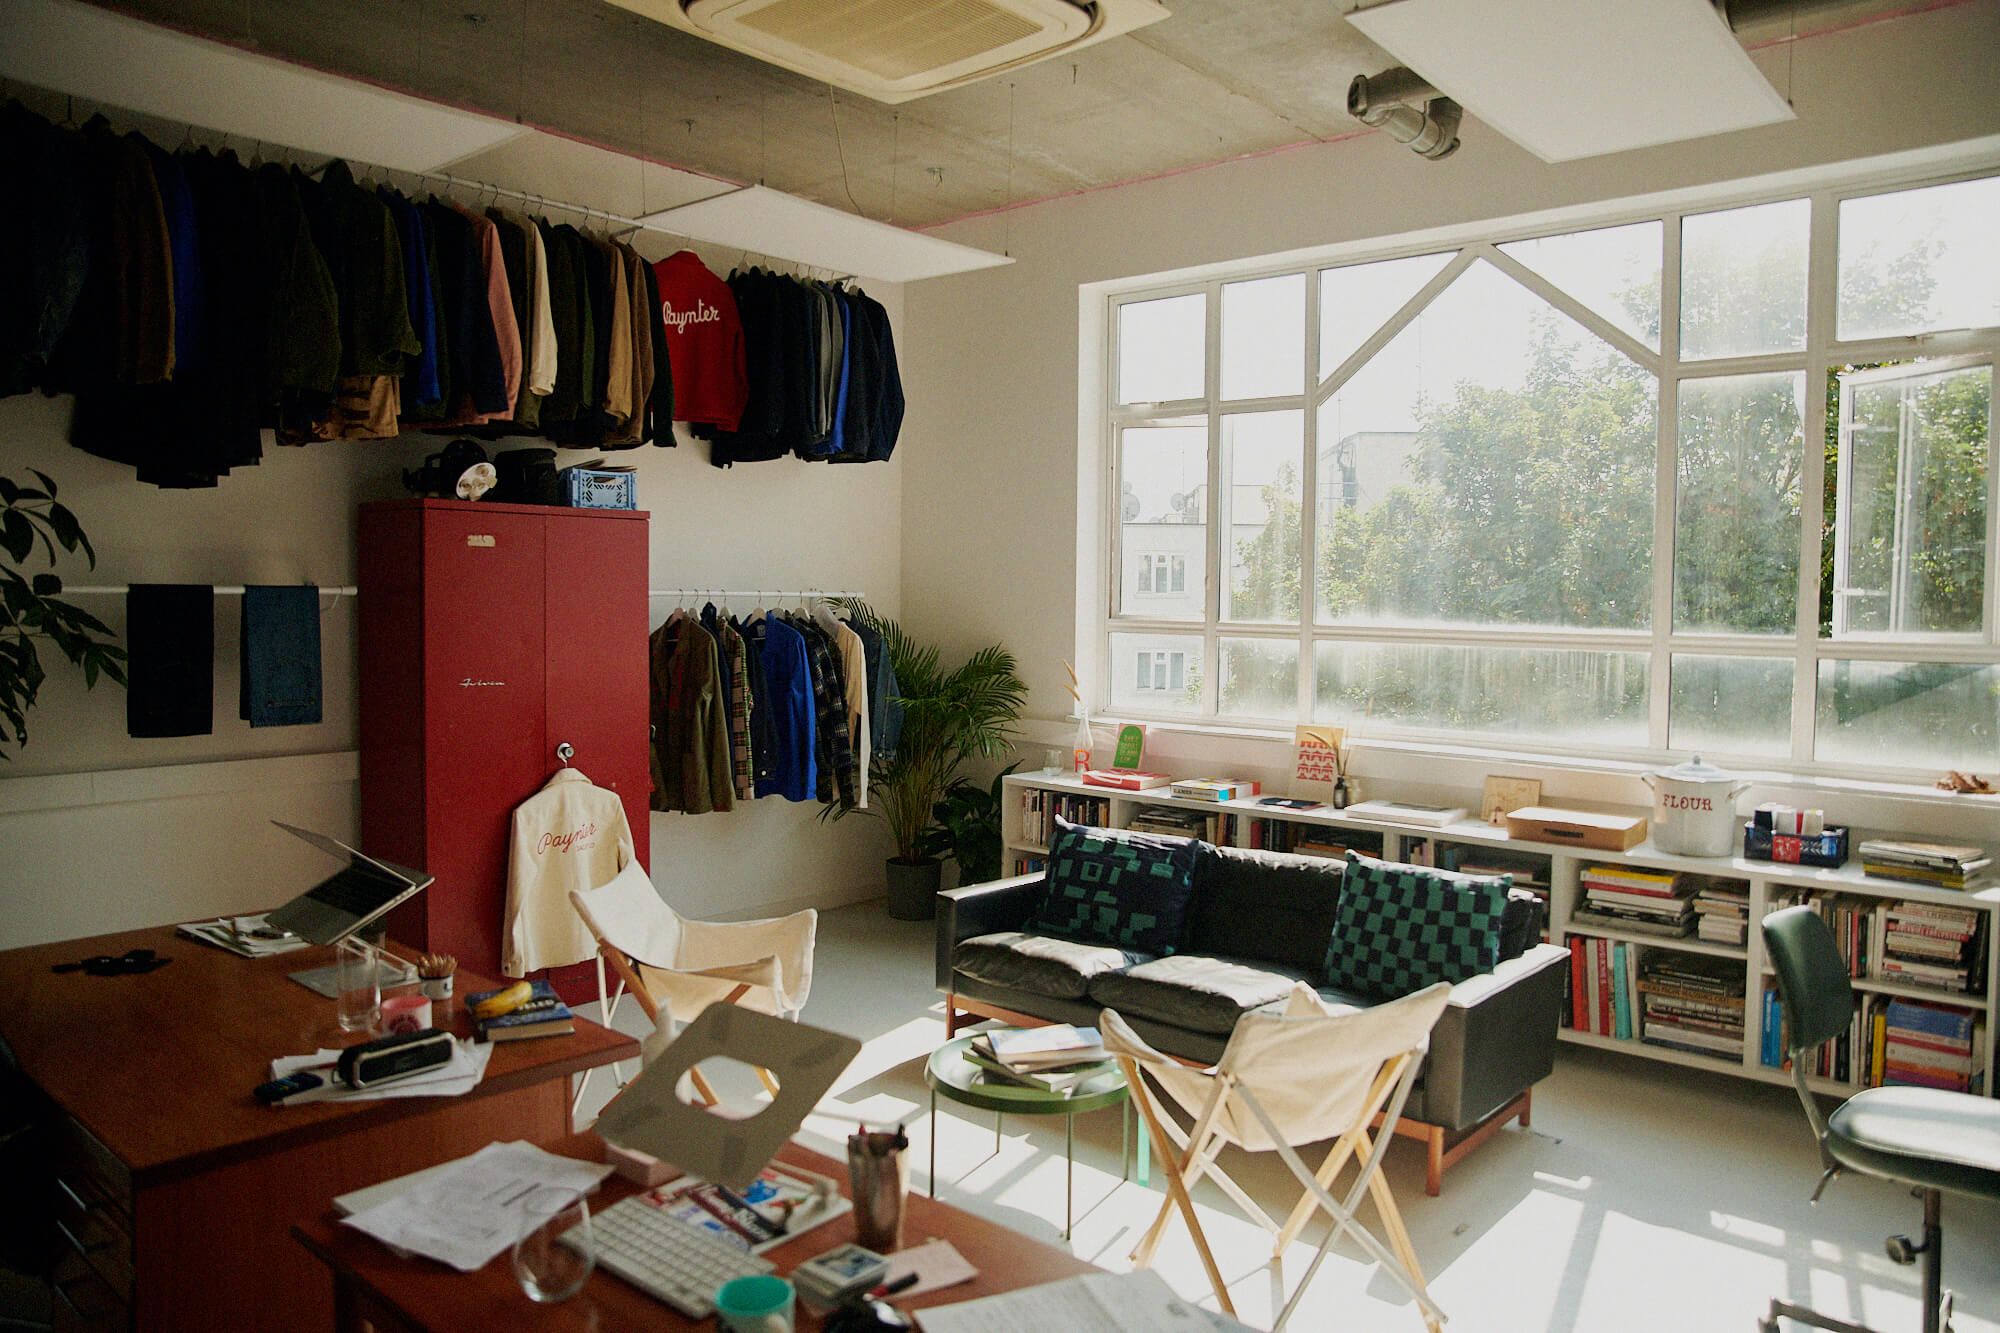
[642,186,1014,282]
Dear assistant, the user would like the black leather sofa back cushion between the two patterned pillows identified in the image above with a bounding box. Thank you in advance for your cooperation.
[1182,843,1346,977]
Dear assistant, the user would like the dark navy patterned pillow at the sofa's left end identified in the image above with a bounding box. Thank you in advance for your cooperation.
[1028,819,1194,955]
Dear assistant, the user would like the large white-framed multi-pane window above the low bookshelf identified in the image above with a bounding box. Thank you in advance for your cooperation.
[1098,174,2000,773]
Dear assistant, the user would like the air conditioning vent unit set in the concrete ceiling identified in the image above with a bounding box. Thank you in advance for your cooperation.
[612,0,1168,102]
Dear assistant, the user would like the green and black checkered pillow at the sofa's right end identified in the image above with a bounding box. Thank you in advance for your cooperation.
[1326,853,1514,999]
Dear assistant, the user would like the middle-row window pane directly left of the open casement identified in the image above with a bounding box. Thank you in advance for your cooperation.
[1674,372,1806,632]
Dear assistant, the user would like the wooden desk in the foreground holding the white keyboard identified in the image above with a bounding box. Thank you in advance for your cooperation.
[292,1135,1098,1333]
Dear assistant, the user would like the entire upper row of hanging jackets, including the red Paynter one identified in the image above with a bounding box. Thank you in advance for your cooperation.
[0,102,902,486]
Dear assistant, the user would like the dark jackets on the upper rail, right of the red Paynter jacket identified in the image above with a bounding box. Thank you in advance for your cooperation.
[688,256,904,468]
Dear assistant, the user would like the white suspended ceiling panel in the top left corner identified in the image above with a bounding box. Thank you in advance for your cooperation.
[0,0,522,172]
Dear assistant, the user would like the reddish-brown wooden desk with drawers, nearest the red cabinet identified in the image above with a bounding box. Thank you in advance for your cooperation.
[0,927,638,1331]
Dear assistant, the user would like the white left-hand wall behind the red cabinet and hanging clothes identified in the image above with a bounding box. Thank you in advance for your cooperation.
[0,238,908,949]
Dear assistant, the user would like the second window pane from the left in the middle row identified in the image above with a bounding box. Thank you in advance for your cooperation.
[1222,412,1306,620]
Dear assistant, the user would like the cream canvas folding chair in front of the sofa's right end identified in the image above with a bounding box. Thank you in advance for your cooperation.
[1098,983,1450,1333]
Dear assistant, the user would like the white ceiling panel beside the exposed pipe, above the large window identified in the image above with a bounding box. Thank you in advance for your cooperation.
[1348,0,1792,162]
